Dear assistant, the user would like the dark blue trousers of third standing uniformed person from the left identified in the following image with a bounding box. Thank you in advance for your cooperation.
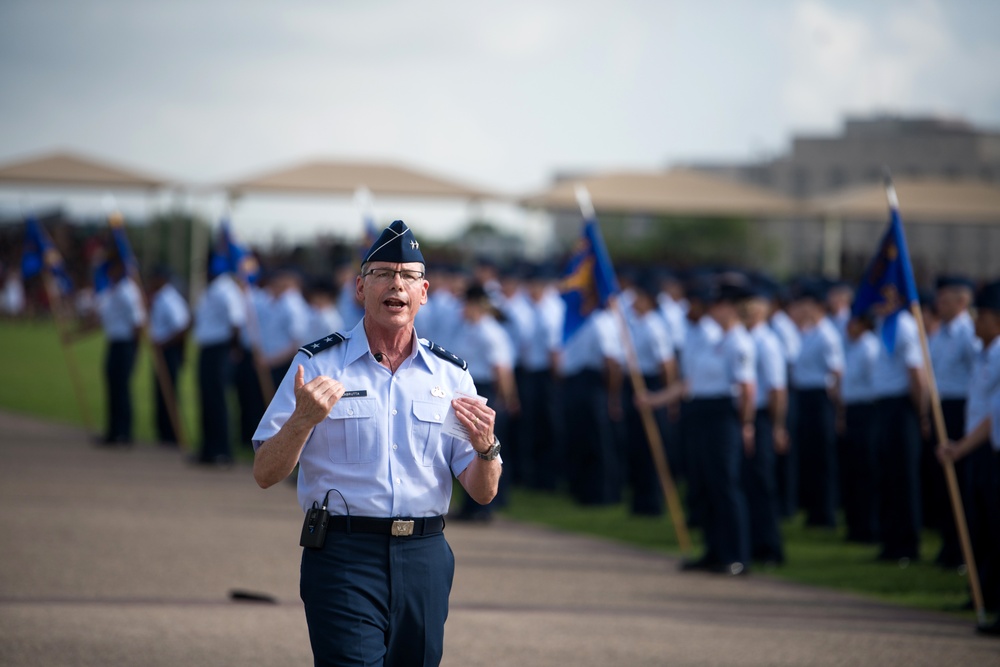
[198,342,232,463]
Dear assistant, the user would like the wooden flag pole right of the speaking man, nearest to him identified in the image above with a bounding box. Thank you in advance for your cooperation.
[576,185,691,554]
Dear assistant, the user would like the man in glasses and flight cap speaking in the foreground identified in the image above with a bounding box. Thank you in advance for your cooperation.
[254,220,501,665]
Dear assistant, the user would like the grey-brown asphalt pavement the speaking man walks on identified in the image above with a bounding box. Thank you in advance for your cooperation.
[0,413,1000,667]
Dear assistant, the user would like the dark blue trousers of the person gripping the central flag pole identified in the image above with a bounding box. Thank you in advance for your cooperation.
[685,397,750,564]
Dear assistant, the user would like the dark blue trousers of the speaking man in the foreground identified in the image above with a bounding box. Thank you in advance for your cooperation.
[300,532,455,667]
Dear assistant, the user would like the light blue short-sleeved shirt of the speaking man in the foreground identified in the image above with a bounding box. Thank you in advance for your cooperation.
[253,322,476,517]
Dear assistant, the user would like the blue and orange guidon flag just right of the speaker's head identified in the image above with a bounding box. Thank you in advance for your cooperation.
[559,192,619,343]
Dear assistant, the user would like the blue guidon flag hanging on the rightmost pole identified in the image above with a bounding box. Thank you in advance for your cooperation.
[851,179,920,354]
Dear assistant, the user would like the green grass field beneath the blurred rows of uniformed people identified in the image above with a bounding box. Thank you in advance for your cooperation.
[0,320,972,618]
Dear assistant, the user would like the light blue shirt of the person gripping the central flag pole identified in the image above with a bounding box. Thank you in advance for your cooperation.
[681,318,757,398]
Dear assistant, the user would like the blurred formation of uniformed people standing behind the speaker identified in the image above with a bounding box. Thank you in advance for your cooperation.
[4,230,1000,608]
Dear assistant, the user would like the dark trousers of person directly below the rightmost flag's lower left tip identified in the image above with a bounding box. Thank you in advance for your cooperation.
[840,403,879,542]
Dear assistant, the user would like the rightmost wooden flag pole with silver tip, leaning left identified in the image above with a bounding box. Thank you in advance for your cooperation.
[885,181,986,624]
